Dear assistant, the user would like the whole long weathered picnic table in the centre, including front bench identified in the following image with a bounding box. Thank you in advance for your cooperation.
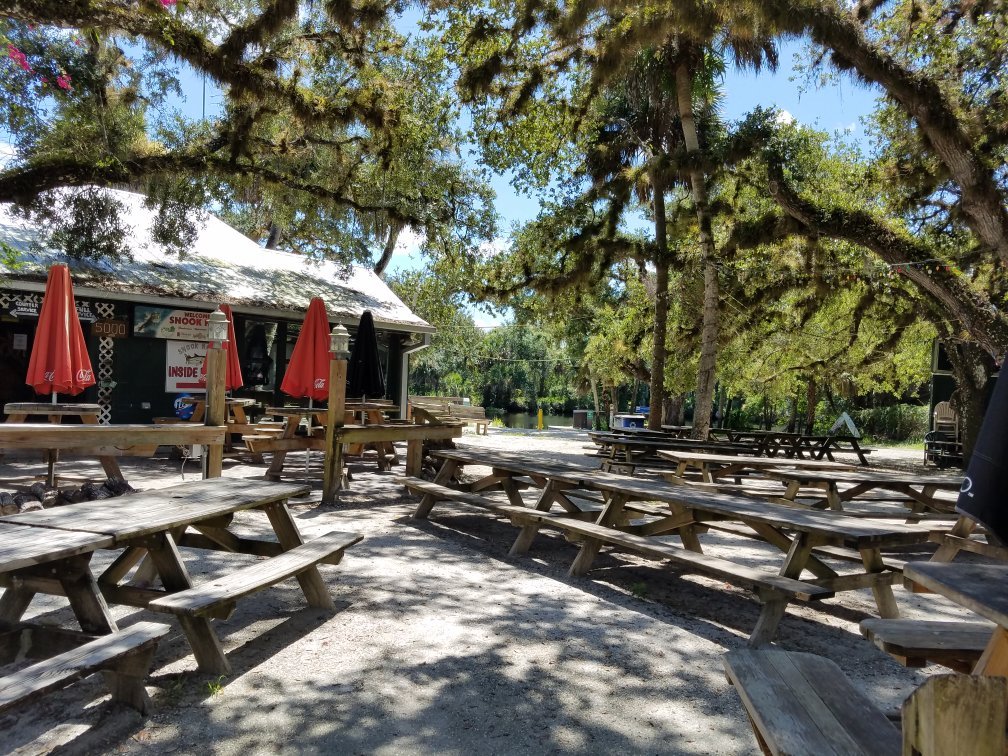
[407,450,928,645]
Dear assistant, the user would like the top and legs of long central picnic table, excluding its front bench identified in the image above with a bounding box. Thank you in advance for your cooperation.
[417,450,928,640]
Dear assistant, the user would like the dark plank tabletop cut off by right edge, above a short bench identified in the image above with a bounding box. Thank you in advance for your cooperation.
[903,561,1008,629]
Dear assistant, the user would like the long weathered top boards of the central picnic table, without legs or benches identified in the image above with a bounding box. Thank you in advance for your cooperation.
[431,449,929,548]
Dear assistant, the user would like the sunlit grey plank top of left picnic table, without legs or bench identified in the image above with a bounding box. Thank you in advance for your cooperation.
[0,478,310,543]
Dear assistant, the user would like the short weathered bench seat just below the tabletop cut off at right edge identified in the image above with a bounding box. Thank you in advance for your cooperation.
[861,618,995,672]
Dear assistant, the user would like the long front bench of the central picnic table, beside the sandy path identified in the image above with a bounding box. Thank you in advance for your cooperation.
[403,478,834,646]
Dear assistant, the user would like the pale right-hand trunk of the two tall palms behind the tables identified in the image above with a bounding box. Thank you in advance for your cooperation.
[675,62,721,438]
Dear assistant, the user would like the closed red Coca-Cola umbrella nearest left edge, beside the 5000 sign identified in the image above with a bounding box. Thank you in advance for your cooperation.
[24,264,95,401]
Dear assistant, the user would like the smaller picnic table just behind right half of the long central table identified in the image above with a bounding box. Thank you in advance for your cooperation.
[763,468,963,512]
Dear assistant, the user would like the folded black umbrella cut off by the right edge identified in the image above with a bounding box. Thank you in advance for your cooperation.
[956,364,1008,543]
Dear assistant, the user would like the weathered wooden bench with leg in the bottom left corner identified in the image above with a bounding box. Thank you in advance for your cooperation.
[0,622,170,714]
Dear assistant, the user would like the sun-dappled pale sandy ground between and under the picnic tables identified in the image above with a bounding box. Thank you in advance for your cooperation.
[0,428,964,754]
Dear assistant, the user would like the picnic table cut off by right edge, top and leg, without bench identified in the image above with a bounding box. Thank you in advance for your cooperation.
[903,561,1008,676]
